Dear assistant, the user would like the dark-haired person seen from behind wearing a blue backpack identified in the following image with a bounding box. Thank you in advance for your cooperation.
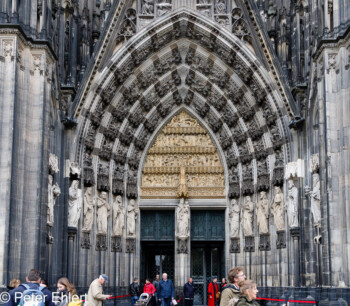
[6,269,53,306]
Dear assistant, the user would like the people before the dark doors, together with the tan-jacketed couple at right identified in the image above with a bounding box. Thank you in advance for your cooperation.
[129,267,258,306]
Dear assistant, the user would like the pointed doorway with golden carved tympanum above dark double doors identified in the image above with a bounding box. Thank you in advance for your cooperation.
[140,110,226,305]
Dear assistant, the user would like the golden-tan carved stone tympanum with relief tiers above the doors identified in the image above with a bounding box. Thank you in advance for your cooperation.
[141,112,225,198]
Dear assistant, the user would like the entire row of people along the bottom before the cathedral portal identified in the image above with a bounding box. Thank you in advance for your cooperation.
[5,267,258,306]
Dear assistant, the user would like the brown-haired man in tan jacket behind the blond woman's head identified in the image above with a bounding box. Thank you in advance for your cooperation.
[220,267,246,306]
